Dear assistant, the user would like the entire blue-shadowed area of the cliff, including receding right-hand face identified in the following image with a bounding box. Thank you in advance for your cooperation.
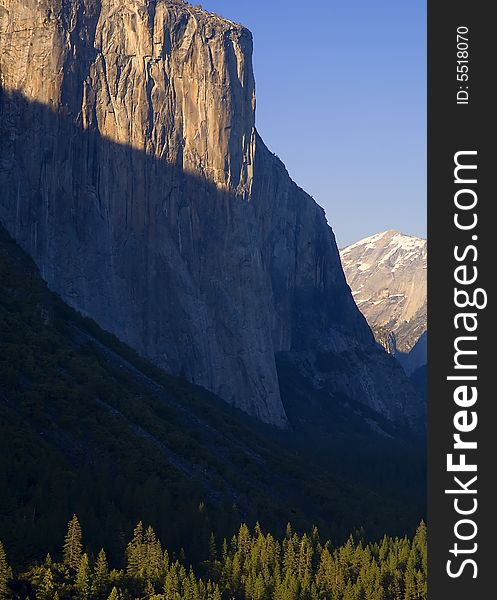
[0,86,423,436]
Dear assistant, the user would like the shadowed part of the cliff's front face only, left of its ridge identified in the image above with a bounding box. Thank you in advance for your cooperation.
[0,92,285,425]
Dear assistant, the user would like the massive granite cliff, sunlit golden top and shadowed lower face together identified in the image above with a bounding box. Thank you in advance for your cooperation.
[0,0,420,426]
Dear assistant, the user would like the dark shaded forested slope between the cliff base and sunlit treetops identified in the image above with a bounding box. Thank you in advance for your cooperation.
[0,229,425,562]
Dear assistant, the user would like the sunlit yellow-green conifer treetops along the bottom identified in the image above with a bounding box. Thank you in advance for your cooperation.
[0,516,427,600]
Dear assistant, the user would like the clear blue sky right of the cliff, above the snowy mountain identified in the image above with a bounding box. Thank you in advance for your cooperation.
[202,0,426,246]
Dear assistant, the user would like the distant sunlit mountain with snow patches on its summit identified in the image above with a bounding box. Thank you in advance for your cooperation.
[340,231,427,372]
